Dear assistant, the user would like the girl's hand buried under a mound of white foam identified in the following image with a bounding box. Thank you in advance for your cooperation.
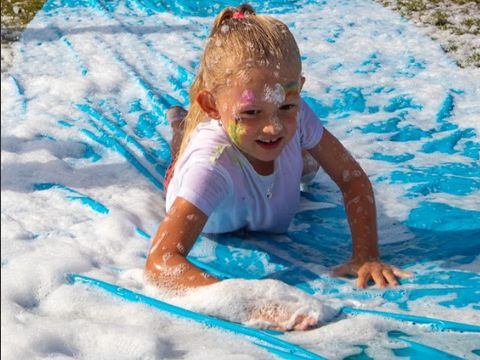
[177,279,340,331]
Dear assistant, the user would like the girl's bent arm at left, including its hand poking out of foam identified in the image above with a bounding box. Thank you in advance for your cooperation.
[145,198,318,331]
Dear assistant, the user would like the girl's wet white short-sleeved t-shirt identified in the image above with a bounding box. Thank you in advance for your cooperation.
[166,100,323,233]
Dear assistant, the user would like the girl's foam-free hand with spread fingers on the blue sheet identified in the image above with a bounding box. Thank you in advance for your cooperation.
[333,259,413,289]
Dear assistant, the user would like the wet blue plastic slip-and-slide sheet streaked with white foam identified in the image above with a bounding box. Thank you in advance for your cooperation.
[2,0,480,359]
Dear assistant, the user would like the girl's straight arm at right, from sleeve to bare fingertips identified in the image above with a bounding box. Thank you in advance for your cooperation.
[308,129,411,288]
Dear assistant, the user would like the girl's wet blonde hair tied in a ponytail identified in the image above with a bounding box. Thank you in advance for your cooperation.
[178,4,302,162]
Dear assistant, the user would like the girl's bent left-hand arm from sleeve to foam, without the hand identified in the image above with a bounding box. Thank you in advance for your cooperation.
[145,197,219,290]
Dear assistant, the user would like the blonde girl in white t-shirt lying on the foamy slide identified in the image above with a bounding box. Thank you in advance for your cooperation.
[145,5,409,329]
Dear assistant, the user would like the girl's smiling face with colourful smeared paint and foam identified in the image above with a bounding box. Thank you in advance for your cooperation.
[215,66,304,171]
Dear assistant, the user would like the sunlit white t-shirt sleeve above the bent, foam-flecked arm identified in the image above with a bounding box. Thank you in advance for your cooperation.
[177,166,231,216]
